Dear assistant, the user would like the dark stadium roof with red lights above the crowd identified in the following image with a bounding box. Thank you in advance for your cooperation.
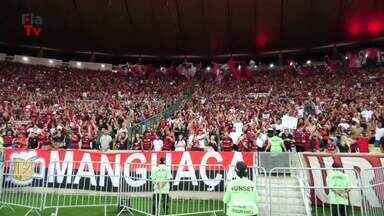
[0,0,384,56]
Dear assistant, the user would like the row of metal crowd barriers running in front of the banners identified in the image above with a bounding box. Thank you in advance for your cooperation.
[0,151,384,216]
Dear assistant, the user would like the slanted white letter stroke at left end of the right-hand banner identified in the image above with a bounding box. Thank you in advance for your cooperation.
[308,156,328,203]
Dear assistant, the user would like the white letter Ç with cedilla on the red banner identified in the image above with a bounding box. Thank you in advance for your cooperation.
[200,151,223,191]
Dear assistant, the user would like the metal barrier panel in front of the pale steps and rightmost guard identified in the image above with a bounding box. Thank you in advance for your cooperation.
[269,167,363,216]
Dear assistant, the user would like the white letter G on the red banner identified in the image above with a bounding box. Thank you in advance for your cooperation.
[124,153,147,187]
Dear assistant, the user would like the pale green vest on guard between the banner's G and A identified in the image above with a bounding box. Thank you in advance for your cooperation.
[151,164,172,194]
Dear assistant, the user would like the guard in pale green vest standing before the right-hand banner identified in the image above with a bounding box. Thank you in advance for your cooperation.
[326,162,350,216]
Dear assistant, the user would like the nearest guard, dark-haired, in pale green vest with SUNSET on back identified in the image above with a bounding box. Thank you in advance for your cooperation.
[223,161,260,216]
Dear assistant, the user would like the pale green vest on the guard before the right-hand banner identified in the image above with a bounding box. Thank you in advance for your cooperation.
[327,170,349,205]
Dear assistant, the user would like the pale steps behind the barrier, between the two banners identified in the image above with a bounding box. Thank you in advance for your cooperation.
[257,176,307,216]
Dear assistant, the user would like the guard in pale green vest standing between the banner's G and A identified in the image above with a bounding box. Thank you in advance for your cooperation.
[151,157,172,215]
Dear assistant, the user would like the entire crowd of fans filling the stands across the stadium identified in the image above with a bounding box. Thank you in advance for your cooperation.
[0,60,384,152]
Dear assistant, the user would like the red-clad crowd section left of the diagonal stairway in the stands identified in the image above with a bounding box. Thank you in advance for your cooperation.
[0,62,188,149]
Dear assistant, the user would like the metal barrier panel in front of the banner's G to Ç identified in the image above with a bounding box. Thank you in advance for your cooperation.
[118,164,226,215]
